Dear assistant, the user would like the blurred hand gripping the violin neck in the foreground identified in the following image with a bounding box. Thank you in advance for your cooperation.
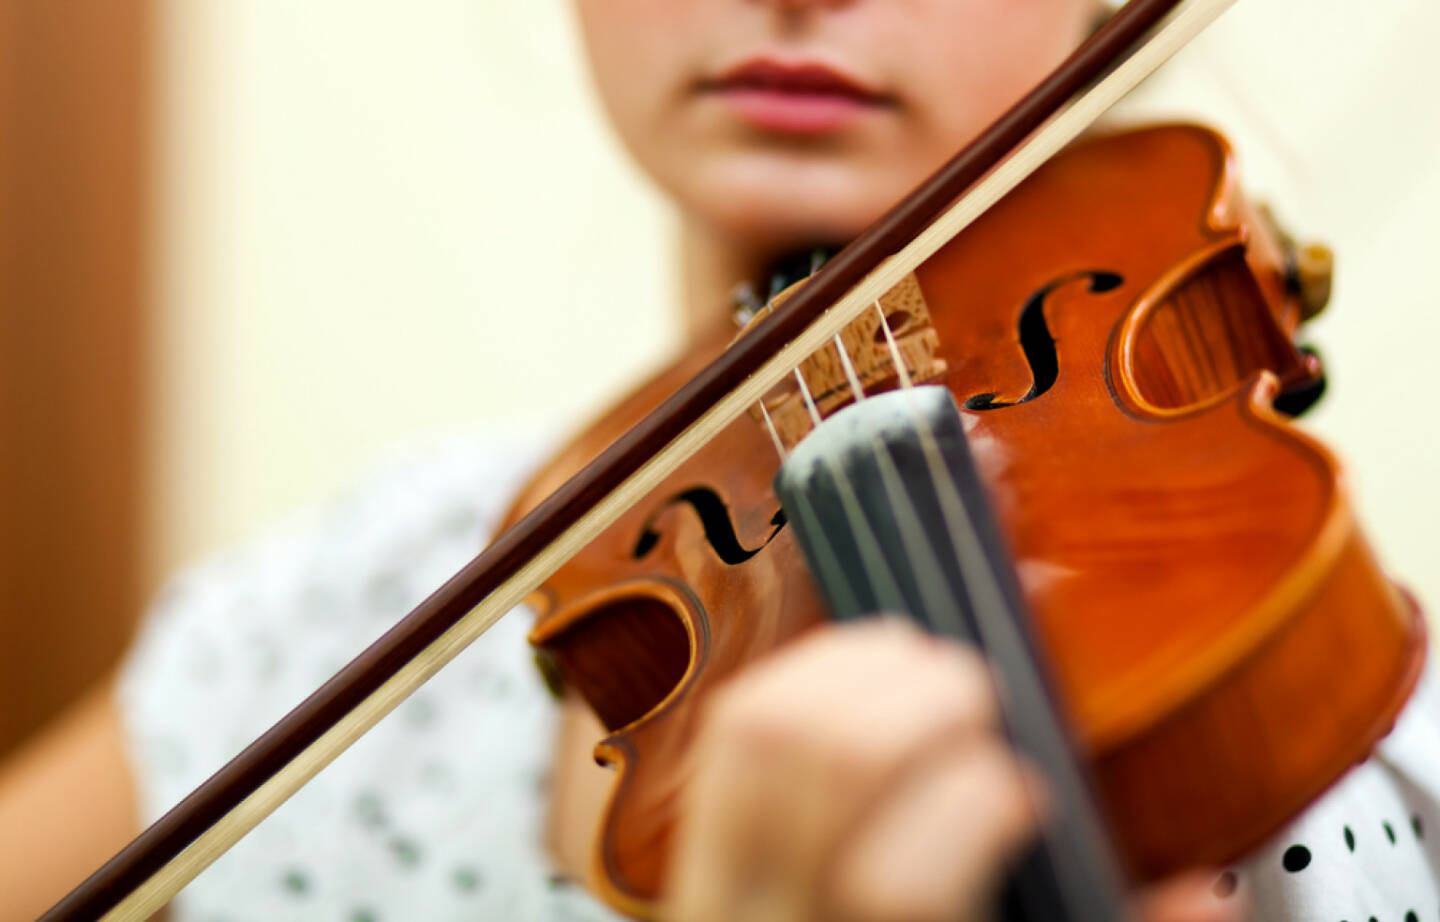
[664,618,1233,922]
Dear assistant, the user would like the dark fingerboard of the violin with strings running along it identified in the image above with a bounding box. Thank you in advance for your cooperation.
[775,388,1129,922]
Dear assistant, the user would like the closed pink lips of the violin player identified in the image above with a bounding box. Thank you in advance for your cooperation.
[700,58,894,134]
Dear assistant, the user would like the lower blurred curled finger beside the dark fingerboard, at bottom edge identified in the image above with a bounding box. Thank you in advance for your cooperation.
[827,739,1044,922]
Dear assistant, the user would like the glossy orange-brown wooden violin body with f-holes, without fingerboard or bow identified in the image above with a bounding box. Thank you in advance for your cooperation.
[501,125,1424,915]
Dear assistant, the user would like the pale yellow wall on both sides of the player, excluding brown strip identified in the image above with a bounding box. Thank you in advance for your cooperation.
[146,0,1440,604]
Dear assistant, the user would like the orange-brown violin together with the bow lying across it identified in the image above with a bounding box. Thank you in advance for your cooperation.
[42,0,1424,919]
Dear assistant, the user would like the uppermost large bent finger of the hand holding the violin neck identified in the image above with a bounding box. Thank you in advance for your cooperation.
[672,624,994,919]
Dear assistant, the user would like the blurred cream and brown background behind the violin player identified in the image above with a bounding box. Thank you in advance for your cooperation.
[0,0,1440,752]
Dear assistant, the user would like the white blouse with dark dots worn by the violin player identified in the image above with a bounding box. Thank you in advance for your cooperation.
[121,432,1440,922]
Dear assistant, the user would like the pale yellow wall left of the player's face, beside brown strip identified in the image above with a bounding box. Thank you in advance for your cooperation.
[153,0,675,576]
